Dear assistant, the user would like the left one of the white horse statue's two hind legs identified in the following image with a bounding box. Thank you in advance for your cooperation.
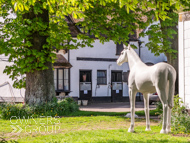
[156,87,168,134]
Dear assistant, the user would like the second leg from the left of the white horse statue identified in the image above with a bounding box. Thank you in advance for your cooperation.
[143,94,151,131]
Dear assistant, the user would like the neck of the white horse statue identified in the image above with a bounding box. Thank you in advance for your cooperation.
[127,48,143,69]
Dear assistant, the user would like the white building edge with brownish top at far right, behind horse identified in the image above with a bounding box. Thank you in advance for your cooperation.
[178,12,190,109]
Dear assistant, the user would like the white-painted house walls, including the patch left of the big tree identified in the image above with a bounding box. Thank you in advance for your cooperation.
[0,13,167,101]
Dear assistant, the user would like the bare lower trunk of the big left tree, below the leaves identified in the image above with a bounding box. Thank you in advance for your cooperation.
[25,63,55,105]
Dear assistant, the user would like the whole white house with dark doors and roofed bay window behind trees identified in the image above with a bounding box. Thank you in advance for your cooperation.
[0,14,166,102]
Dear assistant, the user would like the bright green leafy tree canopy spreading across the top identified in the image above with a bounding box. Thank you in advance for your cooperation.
[0,0,188,88]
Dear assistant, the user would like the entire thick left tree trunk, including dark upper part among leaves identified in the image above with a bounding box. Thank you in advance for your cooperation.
[23,2,55,105]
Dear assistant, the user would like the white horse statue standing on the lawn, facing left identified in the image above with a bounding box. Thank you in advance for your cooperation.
[117,45,176,133]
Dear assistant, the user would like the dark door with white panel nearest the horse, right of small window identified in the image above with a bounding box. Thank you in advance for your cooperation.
[111,71,123,102]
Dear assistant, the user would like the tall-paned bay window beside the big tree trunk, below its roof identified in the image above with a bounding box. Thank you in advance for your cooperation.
[54,69,69,91]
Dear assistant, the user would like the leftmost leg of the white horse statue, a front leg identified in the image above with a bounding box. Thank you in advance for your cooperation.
[128,88,137,132]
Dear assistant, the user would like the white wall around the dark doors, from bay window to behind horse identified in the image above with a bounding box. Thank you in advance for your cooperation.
[69,37,166,97]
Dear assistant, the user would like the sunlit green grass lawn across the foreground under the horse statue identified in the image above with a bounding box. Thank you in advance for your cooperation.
[0,111,190,143]
